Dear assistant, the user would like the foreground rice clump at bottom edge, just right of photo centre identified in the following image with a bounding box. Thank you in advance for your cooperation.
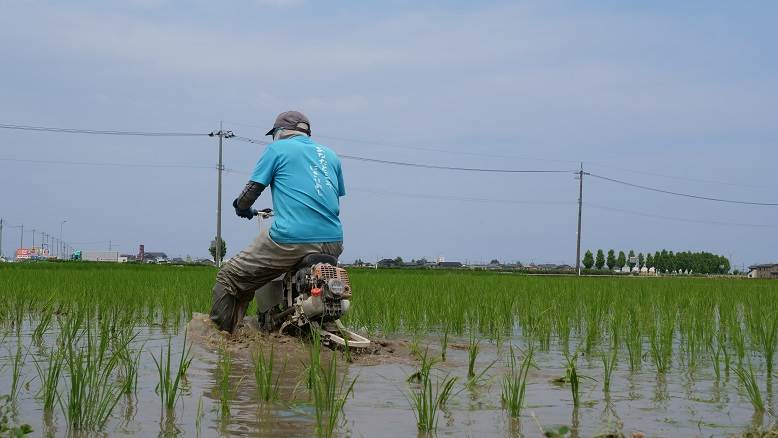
[407,351,457,432]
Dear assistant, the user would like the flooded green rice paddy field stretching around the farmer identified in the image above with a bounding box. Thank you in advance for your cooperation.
[0,262,778,437]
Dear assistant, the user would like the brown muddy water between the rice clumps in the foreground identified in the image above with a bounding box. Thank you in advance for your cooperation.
[0,315,776,437]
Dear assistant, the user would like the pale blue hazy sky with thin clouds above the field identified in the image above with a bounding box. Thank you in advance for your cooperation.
[0,0,778,267]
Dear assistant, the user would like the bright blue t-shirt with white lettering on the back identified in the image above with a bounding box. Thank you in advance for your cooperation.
[251,135,346,243]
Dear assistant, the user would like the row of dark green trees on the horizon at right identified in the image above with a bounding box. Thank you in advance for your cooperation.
[582,249,730,274]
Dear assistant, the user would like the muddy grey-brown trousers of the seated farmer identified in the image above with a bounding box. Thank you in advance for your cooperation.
[211,230,343,333]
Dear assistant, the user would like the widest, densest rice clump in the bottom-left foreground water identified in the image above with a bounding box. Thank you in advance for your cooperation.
[59,322,127,431]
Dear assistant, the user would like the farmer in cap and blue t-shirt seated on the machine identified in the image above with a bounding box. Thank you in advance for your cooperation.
[211,111,346,333]
